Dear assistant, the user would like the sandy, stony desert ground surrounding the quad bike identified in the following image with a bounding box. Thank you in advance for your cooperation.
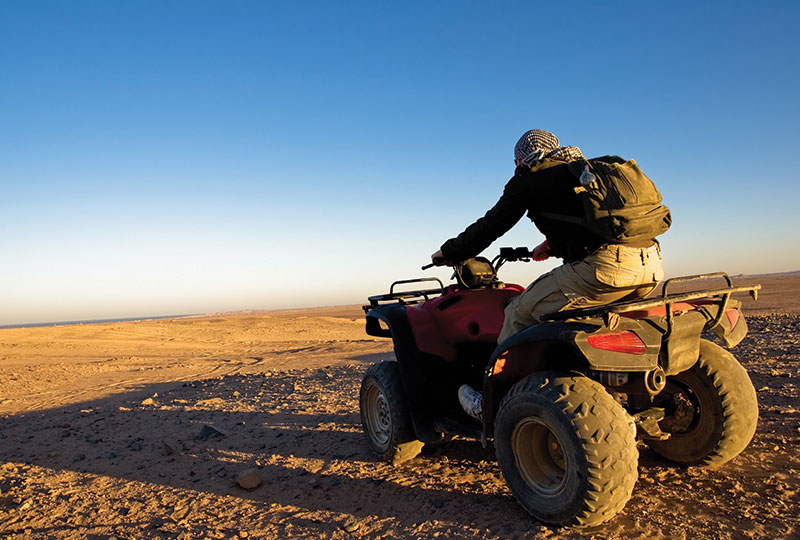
[0,276,800,540]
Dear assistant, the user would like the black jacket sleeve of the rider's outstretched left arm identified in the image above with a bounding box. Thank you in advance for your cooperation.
[441,174,530,261]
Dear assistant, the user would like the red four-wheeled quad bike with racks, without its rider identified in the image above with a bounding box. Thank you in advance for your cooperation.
[360,248,760,527]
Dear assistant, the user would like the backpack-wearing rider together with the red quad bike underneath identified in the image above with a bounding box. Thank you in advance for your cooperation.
[361,130,757,526]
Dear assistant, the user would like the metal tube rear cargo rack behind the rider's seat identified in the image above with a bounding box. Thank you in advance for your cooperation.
[542,272,761,328]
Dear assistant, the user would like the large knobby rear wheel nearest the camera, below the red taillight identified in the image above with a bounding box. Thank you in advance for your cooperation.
[495,373,638,527]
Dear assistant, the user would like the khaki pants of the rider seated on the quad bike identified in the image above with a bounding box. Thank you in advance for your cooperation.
[497,243,664,343]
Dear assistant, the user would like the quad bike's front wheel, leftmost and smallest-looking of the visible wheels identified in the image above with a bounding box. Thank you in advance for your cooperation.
[360,362,423,465]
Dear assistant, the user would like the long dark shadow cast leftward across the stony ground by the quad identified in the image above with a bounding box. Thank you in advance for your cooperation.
[0,360,533,537]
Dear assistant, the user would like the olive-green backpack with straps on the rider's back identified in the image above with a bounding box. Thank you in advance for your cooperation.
[539,156,672,244]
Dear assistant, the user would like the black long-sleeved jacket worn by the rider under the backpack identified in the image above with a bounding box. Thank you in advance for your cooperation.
[442,159,608,262]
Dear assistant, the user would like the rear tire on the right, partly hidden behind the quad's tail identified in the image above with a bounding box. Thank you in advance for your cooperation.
[647,340,758,466]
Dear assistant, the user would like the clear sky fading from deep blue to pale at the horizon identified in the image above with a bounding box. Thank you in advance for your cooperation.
[0,1,800,324]
